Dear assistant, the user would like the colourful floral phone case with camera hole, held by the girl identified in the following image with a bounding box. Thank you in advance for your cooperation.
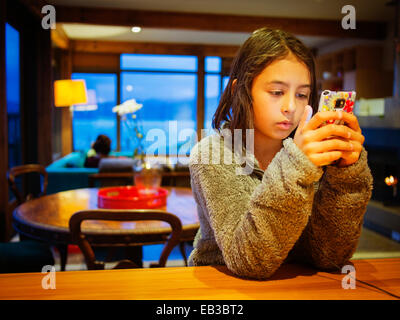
[318,90,356,124]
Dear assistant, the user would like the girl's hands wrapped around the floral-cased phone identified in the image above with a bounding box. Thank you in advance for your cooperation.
[294,106,364,167]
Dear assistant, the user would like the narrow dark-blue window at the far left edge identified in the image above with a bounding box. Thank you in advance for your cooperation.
[6,23,22,168]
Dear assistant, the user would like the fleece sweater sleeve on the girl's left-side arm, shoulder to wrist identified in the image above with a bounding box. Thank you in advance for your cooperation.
[189,138,323,279]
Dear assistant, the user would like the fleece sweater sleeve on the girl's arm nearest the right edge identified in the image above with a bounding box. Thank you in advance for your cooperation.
[293,148,373,270]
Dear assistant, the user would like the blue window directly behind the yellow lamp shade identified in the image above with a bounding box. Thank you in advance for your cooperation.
[72,73,117,151]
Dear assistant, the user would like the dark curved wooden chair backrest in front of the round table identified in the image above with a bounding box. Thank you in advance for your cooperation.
[69,209,182,270]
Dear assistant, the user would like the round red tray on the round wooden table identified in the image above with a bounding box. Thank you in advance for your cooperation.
[97,186,168,209]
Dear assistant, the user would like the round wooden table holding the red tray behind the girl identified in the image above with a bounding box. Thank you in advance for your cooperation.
[13,187,200,270]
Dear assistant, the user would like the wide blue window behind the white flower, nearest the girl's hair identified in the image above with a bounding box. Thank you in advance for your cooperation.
[121,54,197,154]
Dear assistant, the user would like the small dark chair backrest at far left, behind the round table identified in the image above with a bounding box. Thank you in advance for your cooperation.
[7,164,48,204]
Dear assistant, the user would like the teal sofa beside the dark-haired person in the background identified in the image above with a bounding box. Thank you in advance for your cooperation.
[46,152,132,194]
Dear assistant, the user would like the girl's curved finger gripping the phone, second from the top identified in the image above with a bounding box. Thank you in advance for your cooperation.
[304,122,365,144]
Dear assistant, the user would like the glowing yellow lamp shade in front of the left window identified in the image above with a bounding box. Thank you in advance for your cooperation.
[54,80,88,107]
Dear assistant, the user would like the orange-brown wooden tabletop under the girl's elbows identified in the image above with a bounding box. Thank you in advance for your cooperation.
[0,258,400,300]
